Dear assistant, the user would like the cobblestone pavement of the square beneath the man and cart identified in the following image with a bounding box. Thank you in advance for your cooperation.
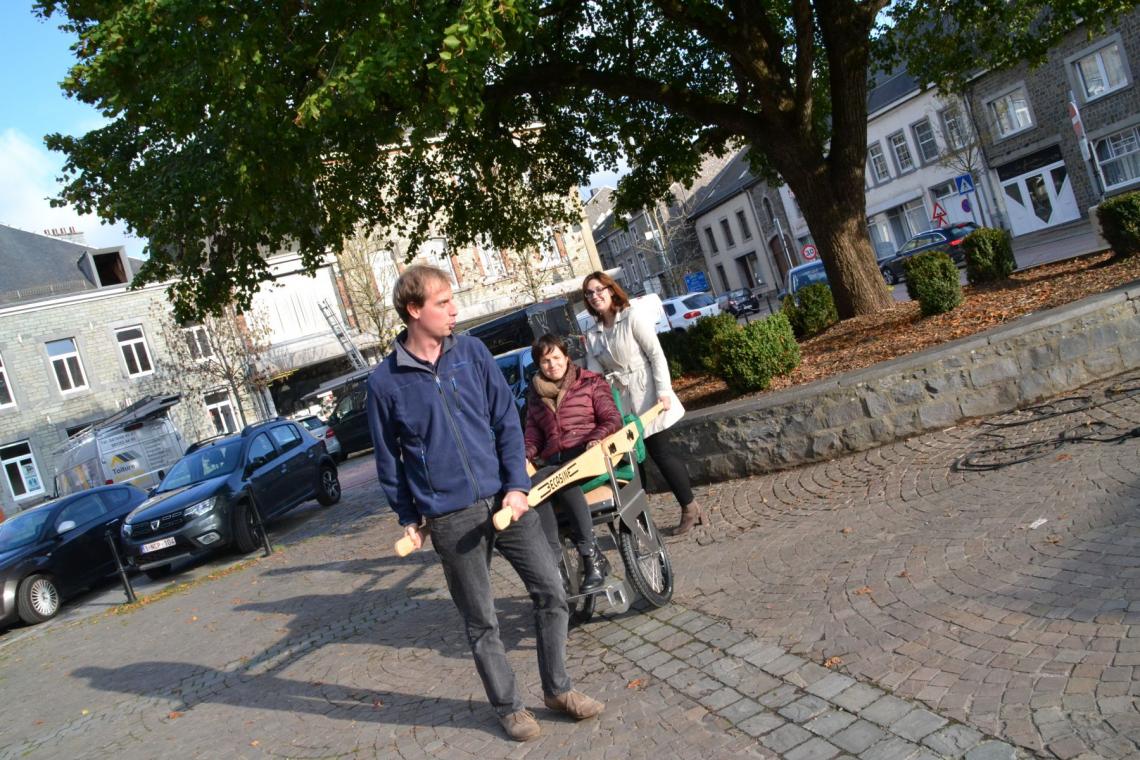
[0,376,1140,760]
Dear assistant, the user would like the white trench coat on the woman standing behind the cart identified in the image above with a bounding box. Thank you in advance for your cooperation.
[586,298,685,436]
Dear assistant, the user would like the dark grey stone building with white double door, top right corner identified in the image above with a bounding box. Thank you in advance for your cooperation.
[968,11,1140,236]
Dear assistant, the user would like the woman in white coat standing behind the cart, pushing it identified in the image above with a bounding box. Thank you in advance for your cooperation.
[581,272,706,536]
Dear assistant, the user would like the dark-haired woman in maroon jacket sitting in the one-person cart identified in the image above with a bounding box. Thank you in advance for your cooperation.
[524,334,621,594]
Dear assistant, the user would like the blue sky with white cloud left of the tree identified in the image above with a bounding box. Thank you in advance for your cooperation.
[0,5,617,262]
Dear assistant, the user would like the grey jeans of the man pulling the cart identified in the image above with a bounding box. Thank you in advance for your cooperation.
[428,499,571,716]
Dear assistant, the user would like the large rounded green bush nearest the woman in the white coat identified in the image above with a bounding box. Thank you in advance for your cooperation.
[711,313,800,393]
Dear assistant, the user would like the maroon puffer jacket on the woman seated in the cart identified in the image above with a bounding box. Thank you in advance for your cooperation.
[524,369,621,461]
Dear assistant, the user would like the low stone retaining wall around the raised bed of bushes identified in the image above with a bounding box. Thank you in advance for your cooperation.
[651,283,1140,490]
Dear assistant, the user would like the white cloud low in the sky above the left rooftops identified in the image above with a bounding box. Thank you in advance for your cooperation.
[0,129,144,256]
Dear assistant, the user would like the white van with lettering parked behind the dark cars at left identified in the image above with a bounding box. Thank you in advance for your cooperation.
[55,394,186,497]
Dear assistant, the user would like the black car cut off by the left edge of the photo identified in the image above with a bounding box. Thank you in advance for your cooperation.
[0,484,146,626]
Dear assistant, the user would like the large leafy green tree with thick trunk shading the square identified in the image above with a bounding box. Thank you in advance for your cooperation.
[35,0,1131,317]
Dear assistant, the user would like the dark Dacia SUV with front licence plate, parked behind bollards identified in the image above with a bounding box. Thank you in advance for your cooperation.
[122,419,341,578]
